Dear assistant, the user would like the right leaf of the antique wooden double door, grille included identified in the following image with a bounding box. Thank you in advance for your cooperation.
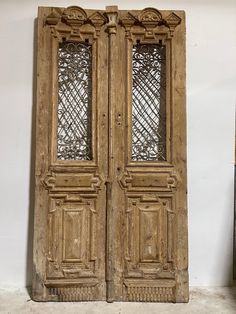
[110,8,188,301]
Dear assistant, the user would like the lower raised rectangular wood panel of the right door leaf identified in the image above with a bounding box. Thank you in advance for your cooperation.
[125,194,176,278]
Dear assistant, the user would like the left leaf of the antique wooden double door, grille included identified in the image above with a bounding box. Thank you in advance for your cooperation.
[33,7,108,301]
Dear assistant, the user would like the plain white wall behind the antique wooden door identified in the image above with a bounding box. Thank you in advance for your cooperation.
[0,0,236,286]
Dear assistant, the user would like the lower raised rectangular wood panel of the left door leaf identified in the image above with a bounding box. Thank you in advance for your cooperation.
[47,199,98,279]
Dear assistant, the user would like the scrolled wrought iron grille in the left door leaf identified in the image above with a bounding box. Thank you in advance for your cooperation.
[57,42,92,160]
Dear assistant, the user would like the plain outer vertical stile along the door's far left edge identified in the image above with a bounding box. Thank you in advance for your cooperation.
[32,8,51,300]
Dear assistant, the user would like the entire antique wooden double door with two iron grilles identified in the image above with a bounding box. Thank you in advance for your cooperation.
[33,6,188,302]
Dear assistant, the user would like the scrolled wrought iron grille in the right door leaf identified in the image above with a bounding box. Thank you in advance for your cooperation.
[132,44,166,161]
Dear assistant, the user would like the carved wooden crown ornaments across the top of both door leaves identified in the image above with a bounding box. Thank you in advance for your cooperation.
[45,6,181,40]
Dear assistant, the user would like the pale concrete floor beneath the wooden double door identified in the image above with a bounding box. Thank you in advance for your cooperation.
[0,287,236,314]
